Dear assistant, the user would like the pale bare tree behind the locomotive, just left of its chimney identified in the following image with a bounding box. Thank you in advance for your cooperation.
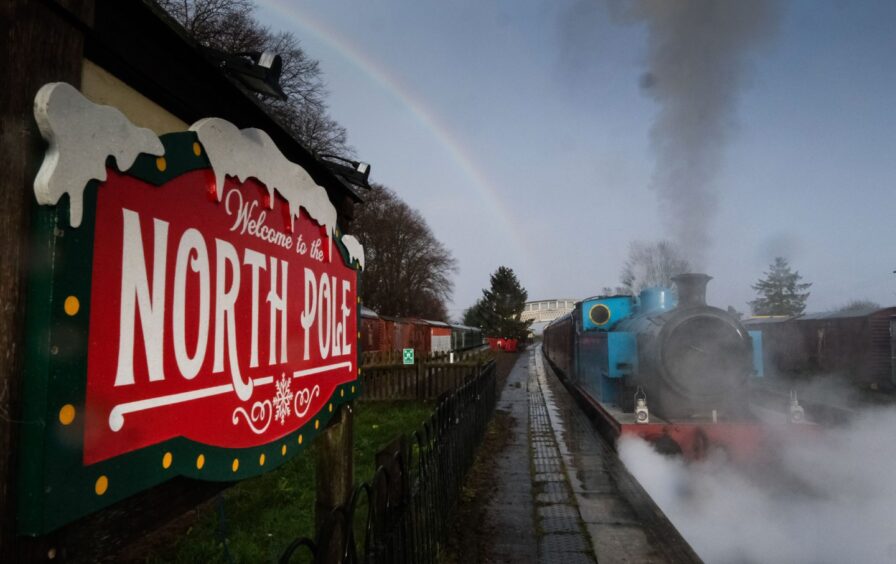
[620,241,691,294]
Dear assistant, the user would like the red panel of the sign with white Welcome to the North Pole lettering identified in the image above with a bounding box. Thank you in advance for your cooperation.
[83,169,358,464]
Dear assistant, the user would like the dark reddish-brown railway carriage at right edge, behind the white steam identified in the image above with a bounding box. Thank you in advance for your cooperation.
[744,307,896,388]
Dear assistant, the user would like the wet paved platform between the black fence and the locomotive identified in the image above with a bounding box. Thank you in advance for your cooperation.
[487,348,700,563]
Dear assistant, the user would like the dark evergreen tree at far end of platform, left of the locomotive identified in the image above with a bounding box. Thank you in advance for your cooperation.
[464,266,532,339]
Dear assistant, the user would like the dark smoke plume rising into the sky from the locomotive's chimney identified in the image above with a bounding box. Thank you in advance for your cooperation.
[609,0,777,267]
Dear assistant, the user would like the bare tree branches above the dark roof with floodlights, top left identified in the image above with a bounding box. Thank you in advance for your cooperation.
[158,0,354,156]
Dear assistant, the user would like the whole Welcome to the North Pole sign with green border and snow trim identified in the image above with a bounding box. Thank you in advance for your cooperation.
[19,83,364,534]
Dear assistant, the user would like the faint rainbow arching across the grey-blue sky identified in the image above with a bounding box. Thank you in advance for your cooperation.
[259,0,527,258]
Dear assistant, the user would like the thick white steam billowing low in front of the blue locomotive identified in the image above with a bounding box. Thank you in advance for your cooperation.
[619,409,896,563]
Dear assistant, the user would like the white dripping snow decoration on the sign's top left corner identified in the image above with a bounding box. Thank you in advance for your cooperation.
[34,82,165,227]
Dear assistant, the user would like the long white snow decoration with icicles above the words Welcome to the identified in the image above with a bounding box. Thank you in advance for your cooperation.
[190,118,336,237]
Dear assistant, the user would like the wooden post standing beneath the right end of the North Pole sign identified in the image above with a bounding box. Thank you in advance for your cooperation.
[314,403,354,563]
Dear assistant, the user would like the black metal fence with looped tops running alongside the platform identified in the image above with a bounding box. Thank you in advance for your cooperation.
[280,361,497,564]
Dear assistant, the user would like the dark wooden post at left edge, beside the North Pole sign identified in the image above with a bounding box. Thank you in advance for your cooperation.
[0,0,93,562]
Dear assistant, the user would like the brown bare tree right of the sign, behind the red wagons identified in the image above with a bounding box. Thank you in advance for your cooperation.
[352,184,457,321]
